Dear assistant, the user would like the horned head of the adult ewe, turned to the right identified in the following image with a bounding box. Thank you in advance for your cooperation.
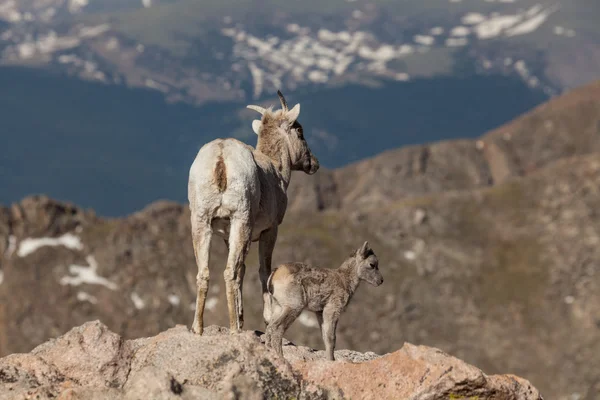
[247,90,319,175]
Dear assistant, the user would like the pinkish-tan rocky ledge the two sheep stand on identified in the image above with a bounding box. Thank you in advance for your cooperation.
[0,321,543,400]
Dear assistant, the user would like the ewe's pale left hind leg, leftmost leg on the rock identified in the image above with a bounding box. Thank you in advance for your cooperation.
[191,214,212,335]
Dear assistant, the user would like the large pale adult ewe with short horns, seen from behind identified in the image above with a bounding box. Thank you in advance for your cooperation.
[188,91,319,335]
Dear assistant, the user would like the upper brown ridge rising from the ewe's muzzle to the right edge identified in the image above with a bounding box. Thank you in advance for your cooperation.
[289,81,600,211]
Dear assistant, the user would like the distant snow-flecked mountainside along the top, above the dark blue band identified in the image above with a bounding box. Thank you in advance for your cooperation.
[0,0,600,104]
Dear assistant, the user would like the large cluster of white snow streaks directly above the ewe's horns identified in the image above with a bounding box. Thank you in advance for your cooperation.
[221,24,422,92]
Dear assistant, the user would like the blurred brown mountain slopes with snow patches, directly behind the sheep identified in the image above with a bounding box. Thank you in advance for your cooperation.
[0,80,600,400]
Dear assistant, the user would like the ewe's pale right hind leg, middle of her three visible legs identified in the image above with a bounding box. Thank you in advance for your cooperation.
[223,218,252,333]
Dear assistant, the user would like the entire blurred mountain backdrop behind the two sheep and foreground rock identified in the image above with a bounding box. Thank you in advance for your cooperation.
[0,0,600,400]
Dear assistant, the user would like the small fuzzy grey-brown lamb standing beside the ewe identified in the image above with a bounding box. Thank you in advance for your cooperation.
[265,242,383,361]
